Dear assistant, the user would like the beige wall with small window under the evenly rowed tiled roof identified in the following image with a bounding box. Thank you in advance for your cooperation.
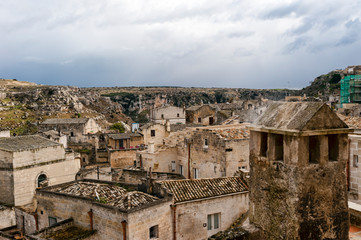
[176,193,248,240]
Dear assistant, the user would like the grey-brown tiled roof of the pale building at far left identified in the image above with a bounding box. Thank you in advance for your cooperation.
[0,135,61,152]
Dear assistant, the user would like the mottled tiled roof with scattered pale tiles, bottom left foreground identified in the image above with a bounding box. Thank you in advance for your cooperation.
[51,182,158,209]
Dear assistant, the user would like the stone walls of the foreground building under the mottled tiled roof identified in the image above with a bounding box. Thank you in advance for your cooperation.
[37,181,171,240]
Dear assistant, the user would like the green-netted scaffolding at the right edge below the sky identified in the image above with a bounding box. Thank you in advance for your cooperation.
[340,75,361,106]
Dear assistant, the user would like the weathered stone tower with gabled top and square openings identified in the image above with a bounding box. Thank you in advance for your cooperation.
[250,102,349,240]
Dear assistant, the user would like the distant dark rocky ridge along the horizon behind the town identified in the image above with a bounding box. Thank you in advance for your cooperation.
[92,87,295,122]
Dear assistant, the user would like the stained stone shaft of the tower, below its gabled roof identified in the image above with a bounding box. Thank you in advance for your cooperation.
[250,131,349,240]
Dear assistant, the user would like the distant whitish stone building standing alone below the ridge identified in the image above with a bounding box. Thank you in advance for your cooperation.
[149,106,186,124]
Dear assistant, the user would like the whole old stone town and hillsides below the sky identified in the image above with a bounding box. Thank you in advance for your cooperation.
[0,66,361,240]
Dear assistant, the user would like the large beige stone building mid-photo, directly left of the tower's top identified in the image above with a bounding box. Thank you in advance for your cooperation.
[137,124,249,178]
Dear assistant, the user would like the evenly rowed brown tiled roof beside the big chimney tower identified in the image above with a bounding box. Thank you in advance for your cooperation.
[161,177,248,203]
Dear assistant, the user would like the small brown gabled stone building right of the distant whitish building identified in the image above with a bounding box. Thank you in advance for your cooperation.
[186,105,217,125]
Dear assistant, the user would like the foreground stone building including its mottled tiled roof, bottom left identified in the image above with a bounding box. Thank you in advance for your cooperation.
[37,180,172,240]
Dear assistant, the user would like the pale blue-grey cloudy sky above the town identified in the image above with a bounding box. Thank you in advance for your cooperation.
[0,0,361,88]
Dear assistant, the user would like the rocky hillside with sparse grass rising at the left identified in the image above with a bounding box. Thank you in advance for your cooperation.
[0,80,131,135]
